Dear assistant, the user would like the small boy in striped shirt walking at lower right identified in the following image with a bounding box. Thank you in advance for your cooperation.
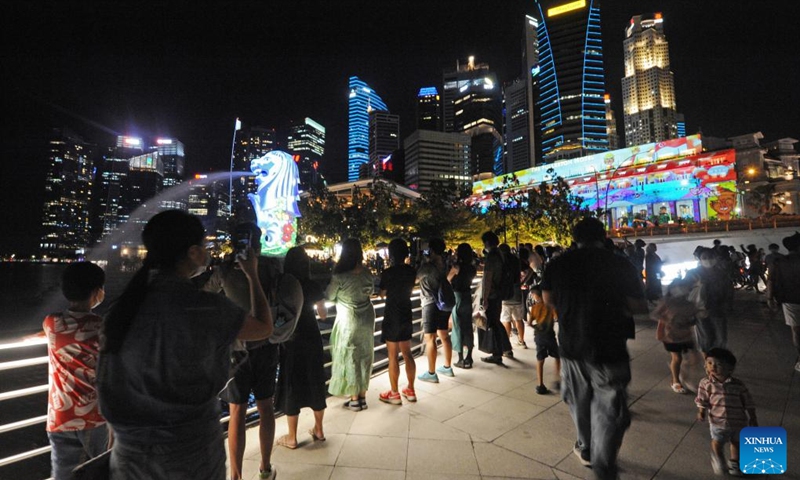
[694,348,758,476]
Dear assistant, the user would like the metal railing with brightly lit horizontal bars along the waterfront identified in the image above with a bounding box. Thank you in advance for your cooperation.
[0,278,479,467]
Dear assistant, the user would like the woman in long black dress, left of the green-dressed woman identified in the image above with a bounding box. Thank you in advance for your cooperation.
[277,247,328,449]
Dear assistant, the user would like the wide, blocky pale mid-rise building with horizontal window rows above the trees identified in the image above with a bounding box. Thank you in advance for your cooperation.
[403,130,472,192]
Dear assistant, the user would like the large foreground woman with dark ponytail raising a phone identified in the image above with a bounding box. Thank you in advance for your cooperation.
[97,210,273,480]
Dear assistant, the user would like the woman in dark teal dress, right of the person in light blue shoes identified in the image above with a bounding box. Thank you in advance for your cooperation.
[447,243,478,368]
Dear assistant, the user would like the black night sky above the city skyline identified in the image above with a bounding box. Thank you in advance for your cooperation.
[0,0,800,253]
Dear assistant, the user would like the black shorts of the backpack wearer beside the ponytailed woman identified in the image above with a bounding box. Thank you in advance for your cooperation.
[219,343,280,405]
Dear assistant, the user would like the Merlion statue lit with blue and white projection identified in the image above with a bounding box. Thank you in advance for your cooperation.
[247,150,300,256]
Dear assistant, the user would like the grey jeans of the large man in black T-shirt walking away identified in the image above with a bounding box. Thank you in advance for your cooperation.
[561,358,631,480]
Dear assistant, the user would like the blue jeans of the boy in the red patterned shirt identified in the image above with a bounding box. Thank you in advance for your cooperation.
[47,426,108,480]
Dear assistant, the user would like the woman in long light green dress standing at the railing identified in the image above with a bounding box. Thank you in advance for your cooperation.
[325,238,375,412]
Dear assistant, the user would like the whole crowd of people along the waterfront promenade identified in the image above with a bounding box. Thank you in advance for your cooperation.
[44,211,800,480]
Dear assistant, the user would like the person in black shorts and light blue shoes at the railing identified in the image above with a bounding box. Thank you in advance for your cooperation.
[417,238,455,383]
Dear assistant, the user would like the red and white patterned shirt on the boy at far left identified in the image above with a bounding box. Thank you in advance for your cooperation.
[43,311,106,432]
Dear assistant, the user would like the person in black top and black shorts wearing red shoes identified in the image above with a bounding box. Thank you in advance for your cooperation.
[378,238,417,405]
